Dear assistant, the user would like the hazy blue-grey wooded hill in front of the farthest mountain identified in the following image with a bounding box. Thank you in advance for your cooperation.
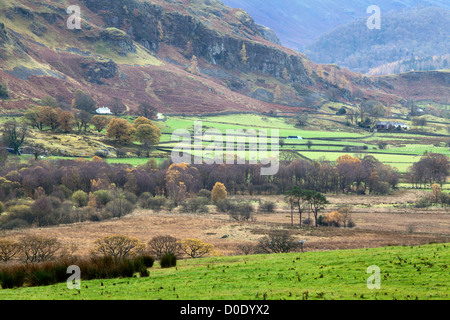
[305,8,450,73]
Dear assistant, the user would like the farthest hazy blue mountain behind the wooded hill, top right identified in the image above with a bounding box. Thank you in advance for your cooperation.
[223,0,450,51]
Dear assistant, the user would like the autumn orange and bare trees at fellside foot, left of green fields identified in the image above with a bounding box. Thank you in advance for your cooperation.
[1,90,161,155]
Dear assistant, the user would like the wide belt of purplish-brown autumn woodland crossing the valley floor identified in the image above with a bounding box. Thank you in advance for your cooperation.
[0,154,449,229]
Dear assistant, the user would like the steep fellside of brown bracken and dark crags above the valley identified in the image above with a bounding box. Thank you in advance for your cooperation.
[0,0,448,113]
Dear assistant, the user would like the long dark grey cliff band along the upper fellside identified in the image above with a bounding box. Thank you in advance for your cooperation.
[82,0,313,85]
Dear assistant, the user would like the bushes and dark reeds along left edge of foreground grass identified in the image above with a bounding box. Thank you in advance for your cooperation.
[0,235,154,289]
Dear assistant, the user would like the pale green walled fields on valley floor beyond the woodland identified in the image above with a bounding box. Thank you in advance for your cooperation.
[156,114,450,173]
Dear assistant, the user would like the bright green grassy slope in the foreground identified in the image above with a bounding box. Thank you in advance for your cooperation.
[0,244,450,300]
